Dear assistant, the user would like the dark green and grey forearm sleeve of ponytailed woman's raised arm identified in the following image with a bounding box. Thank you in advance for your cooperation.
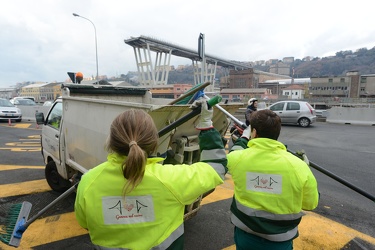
[199,128,228,180]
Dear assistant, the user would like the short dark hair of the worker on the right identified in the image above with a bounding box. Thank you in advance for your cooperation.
[250,109,281,140]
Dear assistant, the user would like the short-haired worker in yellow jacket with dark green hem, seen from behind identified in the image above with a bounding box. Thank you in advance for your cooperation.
[227,110,319,250]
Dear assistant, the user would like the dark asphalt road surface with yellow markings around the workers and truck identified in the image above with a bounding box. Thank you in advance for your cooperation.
[0,122,375,250]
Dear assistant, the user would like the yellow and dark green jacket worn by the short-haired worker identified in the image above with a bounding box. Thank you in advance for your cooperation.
[227,138,318,241]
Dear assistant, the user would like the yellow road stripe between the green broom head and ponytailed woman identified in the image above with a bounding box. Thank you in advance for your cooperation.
[0,212,87,250]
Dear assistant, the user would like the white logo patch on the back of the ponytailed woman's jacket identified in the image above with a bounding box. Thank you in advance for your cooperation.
[102,195,155,225]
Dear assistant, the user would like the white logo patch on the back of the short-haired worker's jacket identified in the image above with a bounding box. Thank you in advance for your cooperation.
[246,172,283,194]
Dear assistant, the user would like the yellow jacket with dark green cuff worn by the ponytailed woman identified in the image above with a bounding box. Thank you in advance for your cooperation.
[75,129,227,249]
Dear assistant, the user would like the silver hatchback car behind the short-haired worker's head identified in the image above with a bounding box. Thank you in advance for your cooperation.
[268,100,316,127]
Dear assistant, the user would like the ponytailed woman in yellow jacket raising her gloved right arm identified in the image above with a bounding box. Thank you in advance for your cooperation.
[75,99,227,250]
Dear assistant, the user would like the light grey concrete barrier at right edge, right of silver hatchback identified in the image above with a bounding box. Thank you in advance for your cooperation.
[326,107,375,126]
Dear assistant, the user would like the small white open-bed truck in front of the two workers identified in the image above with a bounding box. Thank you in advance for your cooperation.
[36,84,242,219]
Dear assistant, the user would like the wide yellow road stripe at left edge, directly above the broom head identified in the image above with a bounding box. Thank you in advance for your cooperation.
[0,179,51,197]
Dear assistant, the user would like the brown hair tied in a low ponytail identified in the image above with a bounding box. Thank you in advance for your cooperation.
[106,109,159,194]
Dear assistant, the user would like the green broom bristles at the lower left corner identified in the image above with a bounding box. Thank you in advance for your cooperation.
[0,203,22,244]
